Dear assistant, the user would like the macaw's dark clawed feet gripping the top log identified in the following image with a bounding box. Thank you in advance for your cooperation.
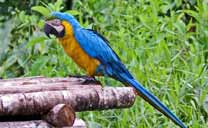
[69,75,101,85]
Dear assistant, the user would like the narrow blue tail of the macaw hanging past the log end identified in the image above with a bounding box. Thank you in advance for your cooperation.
[124,77,186,128]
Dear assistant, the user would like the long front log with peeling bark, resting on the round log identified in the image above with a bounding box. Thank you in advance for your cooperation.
[0,87,135,116]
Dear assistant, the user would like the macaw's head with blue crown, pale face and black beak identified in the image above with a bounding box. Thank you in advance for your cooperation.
[44,12,80,38]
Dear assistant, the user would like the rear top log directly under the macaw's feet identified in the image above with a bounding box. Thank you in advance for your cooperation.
[0,77,102,95]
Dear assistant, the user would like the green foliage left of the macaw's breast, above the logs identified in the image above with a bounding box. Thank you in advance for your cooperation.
[0,0,78,78]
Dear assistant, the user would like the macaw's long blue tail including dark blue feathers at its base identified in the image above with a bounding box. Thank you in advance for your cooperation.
[101,58,186,128]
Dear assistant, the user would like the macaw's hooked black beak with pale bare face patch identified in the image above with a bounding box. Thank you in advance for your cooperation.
[44,19,65,38]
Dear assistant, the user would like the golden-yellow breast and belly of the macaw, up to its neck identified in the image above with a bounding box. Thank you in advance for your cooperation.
[59,22,100,76]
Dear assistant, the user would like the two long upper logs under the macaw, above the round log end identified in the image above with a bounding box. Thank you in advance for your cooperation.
[0,77,135,117]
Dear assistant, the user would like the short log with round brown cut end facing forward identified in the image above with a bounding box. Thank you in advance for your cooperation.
[44,104,75,127]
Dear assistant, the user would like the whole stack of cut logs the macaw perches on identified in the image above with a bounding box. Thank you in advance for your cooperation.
[0,77,135,128]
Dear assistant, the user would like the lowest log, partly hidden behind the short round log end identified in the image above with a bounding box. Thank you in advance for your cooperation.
[0,118,87,128]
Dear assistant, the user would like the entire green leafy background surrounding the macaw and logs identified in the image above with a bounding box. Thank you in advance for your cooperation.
[0,0,208,128]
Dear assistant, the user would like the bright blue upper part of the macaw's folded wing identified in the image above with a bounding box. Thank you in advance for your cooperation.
[74,28,120,64]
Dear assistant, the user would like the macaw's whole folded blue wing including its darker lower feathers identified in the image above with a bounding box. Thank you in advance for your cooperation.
[74,28,133,79]
